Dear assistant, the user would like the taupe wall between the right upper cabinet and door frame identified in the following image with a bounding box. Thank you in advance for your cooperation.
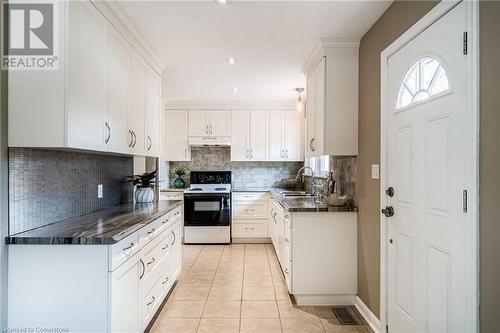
[356,1,436,317]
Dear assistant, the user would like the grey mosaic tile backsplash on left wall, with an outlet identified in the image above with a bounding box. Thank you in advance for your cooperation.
[9,148,134,235]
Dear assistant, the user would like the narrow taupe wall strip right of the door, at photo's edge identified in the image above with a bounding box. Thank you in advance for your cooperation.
[479,1,500,332]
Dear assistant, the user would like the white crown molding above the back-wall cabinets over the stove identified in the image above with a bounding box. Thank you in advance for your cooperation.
[165,101,297,110]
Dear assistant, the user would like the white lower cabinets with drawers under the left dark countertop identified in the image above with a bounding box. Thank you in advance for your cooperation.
[7,206,183,333]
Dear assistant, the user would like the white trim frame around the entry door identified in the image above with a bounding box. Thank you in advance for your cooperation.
[379,0,479,332]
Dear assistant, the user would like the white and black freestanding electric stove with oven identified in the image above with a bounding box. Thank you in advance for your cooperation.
[184,171,231,244]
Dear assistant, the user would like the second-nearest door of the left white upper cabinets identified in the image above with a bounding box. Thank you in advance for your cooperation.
[108,26,133,153]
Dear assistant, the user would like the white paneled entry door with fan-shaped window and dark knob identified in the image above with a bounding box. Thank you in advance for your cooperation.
[385,3,475,332]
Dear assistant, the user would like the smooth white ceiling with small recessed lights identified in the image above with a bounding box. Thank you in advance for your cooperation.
[118,0,390,102]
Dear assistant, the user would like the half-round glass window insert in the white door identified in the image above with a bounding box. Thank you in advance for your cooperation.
[397,56,450,110]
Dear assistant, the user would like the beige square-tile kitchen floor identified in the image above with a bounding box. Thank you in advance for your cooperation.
[151,244,371,333]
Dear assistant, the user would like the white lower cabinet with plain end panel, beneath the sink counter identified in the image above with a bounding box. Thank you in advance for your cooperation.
[269,197,357,306]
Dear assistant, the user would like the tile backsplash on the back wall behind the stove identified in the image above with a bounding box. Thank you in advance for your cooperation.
[170,147,303,188]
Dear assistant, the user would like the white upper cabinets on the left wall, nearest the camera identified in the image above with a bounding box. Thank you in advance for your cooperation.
[9,1,161,156]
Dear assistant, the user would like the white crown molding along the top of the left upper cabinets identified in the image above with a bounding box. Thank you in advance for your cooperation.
[91,0,164,75]
